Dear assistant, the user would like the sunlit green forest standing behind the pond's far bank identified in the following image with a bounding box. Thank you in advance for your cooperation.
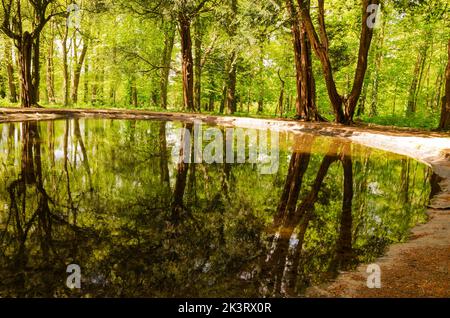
[0,0,450,129]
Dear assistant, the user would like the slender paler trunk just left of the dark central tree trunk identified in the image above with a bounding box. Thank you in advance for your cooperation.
[160,23,175,109]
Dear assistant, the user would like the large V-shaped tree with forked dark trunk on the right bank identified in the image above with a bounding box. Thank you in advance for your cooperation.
[298,0,379,124]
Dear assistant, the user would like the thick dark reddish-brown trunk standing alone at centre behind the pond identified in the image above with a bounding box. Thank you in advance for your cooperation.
[178,13,195,111]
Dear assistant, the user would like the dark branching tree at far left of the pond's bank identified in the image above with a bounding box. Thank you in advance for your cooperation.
[0,0,65,107]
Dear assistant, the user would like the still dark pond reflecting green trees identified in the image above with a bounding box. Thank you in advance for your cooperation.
[0,119,433,297]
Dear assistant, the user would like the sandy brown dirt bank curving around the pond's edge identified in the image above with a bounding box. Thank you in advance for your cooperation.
[0,108,450,297]
